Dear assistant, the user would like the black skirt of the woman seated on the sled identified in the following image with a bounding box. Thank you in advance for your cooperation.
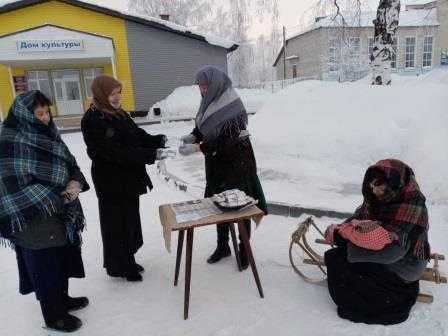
[325,247,419,325]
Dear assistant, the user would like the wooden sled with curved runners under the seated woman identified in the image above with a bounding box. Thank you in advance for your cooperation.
[289,217,447,303]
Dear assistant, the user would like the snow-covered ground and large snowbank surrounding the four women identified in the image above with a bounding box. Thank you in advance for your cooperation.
[0,72,448,336]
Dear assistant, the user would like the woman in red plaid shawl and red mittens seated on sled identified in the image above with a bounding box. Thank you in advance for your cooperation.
[325,159,430,325]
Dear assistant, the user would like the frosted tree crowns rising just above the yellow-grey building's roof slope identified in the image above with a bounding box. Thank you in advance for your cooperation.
[128,0,212,27]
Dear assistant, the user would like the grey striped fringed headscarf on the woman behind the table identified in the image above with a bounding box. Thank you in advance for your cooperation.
[196,66,247,140]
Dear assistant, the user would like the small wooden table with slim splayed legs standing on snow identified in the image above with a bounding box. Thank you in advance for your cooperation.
[159,204,264,320]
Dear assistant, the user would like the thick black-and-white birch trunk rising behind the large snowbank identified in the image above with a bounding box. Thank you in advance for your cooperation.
[370,0,400,85]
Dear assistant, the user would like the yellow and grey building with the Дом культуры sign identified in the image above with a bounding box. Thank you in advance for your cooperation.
[0,0,238,120]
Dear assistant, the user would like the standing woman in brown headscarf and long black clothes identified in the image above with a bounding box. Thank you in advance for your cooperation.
[81,75,166,281]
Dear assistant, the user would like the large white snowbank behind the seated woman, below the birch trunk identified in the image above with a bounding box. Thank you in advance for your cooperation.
[251,70,448,203]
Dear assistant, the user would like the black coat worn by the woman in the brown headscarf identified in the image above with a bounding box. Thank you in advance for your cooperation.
[81,105,164,198]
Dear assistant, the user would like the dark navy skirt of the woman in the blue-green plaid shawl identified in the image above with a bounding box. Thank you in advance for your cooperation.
[15,245,85,301]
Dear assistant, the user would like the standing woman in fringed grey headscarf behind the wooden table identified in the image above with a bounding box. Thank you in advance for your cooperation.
[179,66,267,268]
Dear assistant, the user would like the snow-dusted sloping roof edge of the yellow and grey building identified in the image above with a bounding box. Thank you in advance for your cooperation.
[0,0,238,52]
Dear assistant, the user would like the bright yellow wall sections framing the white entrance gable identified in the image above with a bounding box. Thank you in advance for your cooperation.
[0,1,134,115]
